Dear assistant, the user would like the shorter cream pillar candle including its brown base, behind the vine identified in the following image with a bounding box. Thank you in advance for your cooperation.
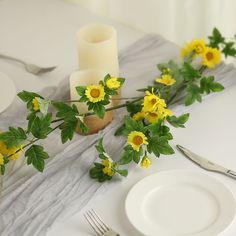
[70,69,113,134]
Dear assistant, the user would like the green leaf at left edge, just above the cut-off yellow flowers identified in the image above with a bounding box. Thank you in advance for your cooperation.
[0,127,27,148]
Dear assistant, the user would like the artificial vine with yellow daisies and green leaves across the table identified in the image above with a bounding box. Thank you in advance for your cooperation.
[0,28,236,182]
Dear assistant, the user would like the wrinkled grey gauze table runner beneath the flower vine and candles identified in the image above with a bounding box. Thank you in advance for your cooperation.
[0,35,236,236]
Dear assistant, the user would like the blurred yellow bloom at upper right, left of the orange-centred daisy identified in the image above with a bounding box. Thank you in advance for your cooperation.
[181,39,206,58]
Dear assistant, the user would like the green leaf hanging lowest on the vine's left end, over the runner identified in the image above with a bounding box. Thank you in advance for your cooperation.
[25,145,49,172]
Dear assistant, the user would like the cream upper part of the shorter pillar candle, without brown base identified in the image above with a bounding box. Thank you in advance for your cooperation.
[70,69,107,113]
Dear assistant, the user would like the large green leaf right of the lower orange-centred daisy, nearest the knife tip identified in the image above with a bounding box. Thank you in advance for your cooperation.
[148,136,174,157]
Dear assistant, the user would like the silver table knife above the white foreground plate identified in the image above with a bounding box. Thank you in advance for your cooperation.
[176,145,236,179]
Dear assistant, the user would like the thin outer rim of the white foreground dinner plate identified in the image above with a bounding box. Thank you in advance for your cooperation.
[124,169,236,236]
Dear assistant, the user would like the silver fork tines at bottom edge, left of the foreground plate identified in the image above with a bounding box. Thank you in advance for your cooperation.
[84,209,120,236]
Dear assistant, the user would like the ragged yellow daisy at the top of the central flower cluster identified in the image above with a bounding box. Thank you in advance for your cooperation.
[143,91,166,112]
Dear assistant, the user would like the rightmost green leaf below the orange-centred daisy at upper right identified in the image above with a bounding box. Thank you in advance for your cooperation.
[200,76,224,94]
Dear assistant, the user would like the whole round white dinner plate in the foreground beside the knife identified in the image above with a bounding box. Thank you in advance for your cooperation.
[125,170,236,236]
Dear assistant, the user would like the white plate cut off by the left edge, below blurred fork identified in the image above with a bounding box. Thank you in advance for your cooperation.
[0,72,16,113]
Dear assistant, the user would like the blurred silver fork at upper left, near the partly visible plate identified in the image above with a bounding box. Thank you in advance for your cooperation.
[0,54,56,75]
